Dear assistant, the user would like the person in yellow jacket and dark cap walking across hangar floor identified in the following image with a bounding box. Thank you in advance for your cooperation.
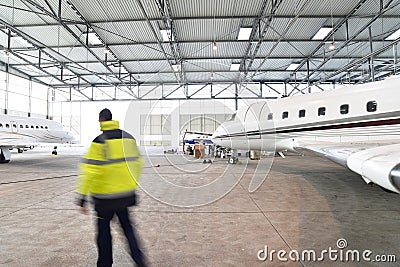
[77,109,147,267]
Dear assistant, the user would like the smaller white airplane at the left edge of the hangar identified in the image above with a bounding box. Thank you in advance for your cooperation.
[0,115,74,163]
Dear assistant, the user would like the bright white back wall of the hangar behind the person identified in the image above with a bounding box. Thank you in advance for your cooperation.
[57,100,238,148]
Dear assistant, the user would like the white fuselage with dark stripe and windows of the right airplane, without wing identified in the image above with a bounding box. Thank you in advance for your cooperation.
[212,77,400,151]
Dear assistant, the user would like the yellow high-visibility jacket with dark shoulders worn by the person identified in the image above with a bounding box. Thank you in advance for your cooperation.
[77,120,143,206]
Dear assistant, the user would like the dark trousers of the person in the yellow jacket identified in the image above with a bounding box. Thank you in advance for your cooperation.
[96,208,146,267]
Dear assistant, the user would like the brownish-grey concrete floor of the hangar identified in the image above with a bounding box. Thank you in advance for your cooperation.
[0,148,400,267]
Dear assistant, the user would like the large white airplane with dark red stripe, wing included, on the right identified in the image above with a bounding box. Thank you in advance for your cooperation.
[212,76,400,193]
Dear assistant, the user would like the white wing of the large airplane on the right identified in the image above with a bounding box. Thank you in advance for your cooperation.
[295,142,400,193]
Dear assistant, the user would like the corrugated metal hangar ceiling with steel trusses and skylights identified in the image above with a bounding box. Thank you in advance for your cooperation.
[0,0,400,100]
